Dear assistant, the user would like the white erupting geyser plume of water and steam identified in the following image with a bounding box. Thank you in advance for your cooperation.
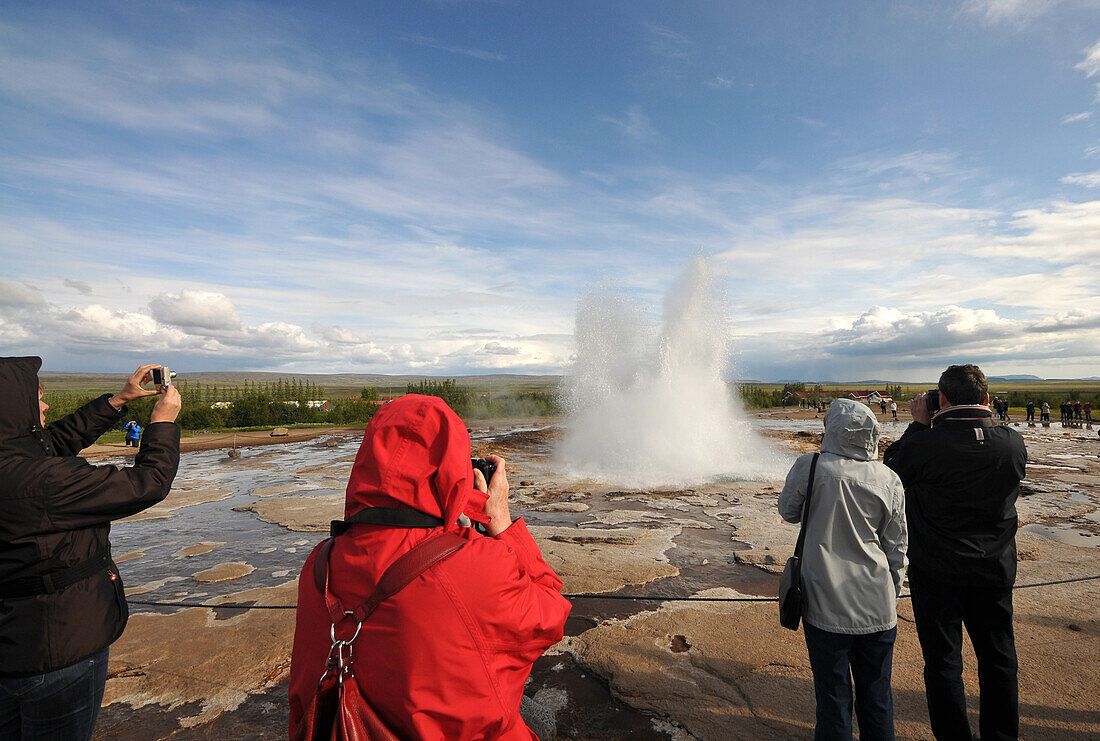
[559,257,790,487]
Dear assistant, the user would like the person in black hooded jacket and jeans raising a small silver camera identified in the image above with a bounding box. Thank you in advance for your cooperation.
[0,357,180,741]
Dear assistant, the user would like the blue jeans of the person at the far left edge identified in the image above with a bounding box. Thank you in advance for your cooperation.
[0,649,108,741]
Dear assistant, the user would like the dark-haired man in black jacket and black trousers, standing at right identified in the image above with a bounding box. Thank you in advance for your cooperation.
[883,365,1027,741]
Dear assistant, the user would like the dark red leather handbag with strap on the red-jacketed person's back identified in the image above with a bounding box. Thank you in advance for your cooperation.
[292,532,466,741]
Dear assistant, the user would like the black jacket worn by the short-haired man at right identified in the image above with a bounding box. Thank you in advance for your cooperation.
[882,407,1027,589]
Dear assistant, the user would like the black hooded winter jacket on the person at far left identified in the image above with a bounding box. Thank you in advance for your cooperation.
[0,357,179,677]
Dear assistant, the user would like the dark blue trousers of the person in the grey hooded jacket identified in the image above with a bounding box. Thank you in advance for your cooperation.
[802,622,898,741]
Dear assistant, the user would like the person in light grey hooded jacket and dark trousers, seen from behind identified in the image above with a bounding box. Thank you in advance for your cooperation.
[779,399,908,741]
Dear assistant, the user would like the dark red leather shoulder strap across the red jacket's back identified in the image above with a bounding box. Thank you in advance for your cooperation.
[314,532,466,623]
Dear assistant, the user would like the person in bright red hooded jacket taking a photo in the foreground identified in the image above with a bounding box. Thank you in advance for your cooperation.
[289,394,571,741]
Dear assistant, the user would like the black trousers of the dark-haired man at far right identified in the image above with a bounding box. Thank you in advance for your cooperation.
[909,572,1020,741]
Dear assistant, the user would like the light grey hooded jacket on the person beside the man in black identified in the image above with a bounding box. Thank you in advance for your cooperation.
[779,399,908,634]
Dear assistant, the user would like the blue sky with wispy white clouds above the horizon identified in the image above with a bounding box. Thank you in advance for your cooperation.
[0,0,1100,380]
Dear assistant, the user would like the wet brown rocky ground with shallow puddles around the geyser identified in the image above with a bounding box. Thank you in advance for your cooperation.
[88,412,1100,740]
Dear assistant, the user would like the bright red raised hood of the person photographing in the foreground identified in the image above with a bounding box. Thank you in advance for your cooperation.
[344,394,487,526]
